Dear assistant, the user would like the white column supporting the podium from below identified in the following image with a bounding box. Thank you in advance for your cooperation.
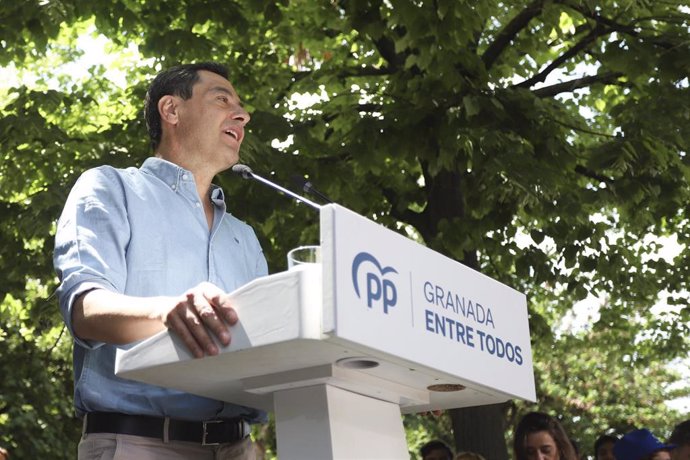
[273,384,410,460]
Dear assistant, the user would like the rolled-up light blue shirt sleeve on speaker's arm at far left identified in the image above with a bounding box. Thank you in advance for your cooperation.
[53,167,130,348]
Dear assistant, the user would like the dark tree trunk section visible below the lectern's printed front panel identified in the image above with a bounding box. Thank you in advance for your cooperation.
[449,403,508,460]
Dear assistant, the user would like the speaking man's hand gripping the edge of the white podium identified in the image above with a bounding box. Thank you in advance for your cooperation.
[162,283,238,358]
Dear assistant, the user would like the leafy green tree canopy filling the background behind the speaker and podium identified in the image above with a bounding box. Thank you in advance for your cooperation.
[0,0,690,459]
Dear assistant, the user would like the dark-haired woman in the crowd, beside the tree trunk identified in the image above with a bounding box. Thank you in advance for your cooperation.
[513,412,577,460]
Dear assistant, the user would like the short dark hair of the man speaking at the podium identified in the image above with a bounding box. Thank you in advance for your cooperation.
[144,62,228,151]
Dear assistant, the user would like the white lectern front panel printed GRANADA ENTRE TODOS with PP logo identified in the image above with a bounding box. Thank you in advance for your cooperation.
[321,205,535,400]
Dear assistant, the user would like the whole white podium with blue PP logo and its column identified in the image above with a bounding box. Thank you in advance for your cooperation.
[116,205,535,460]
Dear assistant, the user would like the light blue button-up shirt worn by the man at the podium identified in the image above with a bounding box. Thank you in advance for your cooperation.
[53,158,268,421]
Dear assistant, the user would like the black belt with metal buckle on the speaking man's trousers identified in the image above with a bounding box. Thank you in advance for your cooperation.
[84,412,249,446]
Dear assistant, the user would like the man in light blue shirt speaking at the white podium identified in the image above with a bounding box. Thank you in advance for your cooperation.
[54,63,267,459]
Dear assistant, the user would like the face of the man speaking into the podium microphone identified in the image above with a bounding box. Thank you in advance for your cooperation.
[177,70,249,174]
